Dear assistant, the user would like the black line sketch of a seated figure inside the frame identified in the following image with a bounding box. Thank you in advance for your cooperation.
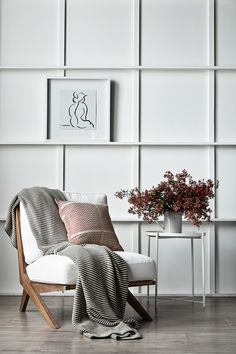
[68,91,94,129]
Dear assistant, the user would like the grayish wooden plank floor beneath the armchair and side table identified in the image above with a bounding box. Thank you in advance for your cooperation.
[0,296,236,354]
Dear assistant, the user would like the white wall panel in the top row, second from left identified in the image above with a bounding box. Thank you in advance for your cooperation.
[66,0,133,67]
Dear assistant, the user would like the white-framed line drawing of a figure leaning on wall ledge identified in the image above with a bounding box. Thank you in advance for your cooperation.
[46,77,110,143]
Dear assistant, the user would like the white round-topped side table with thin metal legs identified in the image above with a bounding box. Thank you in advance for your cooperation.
[146,231,206,307]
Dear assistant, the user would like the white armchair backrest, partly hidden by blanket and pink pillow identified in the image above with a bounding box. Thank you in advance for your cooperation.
[20,192,107,264]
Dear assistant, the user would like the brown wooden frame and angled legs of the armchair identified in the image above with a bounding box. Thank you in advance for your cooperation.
[16,207,155,329]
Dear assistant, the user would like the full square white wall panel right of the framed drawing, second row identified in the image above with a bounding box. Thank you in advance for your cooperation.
[141,71,208,142]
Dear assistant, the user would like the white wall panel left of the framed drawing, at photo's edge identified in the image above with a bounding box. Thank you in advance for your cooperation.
[0,70,60,143]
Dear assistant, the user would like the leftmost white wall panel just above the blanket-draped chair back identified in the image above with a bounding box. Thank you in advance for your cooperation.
[0,145,59,219]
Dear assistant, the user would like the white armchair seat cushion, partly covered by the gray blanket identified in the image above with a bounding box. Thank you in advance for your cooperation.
[26,251,156,285]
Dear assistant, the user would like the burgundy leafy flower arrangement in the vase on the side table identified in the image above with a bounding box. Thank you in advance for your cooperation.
[115,170,219,227]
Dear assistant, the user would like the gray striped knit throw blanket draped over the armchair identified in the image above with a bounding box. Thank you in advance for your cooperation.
[5,187,141,339]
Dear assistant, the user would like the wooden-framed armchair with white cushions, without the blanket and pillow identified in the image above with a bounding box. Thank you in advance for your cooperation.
[13,193,156,328]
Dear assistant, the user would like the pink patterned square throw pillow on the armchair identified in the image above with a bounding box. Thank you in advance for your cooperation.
[57,201,123,251]
